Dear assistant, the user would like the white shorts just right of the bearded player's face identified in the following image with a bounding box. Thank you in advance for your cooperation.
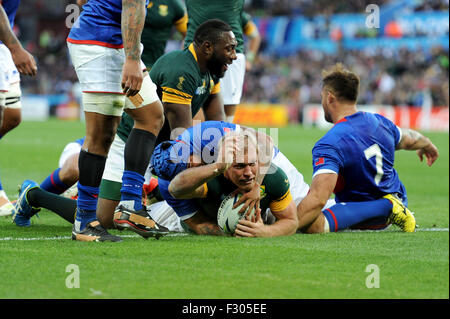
[220,53,245,105]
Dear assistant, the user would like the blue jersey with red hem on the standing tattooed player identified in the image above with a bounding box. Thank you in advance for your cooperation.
[67,0,149,49]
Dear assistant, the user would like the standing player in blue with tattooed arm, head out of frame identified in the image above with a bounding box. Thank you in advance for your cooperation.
[67,0,164,241]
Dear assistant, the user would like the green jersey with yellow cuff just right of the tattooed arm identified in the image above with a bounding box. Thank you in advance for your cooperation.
[141,0,187,70]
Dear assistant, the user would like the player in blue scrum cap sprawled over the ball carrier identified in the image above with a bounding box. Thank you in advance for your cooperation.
[115,117,334,235]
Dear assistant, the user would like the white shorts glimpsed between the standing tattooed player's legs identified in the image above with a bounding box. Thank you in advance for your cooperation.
[102,134,152,184]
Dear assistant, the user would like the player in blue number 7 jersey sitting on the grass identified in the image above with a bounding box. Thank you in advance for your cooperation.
[298,64,439,233]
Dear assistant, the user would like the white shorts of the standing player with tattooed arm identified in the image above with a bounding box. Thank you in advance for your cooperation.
[67,42,159,116]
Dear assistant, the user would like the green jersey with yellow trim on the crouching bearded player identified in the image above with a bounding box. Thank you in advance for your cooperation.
[117,44,220,141]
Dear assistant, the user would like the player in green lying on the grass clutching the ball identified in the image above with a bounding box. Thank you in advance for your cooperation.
[168,133,298,237]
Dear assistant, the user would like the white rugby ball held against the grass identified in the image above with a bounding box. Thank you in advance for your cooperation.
[217,193,255,234]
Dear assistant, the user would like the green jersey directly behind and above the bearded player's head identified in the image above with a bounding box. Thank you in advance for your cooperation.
[184,0,244,53]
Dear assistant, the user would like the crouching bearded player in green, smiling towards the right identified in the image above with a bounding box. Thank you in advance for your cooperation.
[97,19,236,235]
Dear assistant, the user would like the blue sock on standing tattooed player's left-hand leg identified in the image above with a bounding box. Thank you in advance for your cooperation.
[75,182,99,231]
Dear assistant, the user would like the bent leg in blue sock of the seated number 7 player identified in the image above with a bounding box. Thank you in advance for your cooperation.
[302,198,392,234]
